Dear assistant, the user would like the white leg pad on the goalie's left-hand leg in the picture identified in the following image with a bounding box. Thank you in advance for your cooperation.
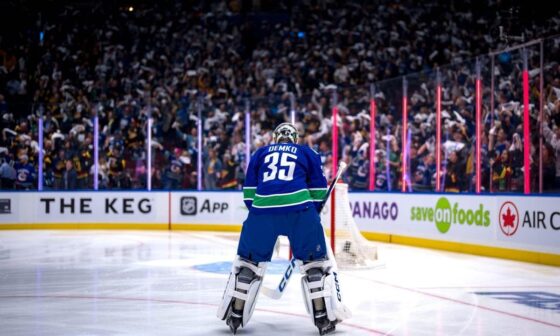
[216,256,268,326]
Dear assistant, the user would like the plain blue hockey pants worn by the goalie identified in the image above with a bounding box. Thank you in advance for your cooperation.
[237,207,327,263]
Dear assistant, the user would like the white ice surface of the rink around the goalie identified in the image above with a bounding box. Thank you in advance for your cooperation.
[0,231,560,336]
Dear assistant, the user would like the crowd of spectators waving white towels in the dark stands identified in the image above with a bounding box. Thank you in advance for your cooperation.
[0,0,560,192]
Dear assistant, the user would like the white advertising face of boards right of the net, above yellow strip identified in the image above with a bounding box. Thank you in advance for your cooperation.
[350,193,560,254]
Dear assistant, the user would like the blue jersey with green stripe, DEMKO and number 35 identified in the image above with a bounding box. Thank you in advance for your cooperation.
[243,143,327,214]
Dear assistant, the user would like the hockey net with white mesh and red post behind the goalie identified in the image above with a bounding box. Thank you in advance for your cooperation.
[321,183,379,269]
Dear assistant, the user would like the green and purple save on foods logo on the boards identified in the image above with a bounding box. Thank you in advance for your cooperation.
[410,197,490,233]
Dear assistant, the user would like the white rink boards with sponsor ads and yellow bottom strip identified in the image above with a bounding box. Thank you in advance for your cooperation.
[0,191,560,266]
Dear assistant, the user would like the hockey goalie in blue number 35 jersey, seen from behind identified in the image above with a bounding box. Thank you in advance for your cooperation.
[217,123,351,335]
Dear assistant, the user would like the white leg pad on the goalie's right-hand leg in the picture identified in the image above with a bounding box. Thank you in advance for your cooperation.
[300,260,352,322]
